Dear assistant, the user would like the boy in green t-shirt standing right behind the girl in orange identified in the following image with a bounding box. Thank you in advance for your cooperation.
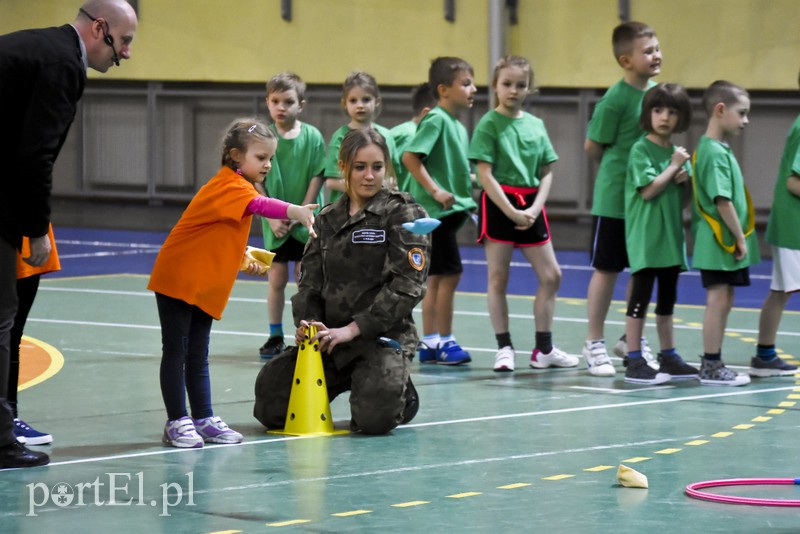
[258,72,325,360]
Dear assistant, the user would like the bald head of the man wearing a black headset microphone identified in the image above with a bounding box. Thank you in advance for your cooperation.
[72,0,139,72]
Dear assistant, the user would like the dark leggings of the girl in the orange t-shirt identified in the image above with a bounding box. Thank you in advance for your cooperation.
[156,293,214,421]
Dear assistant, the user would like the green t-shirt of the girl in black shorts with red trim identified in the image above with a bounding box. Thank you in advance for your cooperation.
[468,110,558,187]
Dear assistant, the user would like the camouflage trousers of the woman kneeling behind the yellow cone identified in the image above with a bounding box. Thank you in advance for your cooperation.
[253,342,409,434]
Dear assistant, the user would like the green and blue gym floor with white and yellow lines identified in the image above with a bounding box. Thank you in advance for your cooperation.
[0,228,800,533]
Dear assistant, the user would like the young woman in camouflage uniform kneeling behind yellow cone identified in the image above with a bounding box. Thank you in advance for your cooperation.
[254,128,430,434]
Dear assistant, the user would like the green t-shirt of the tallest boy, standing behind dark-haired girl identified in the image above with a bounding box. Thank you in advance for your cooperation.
[586,80,655,219]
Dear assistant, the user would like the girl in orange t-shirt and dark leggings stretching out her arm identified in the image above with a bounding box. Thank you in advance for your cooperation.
[147,119,318,448]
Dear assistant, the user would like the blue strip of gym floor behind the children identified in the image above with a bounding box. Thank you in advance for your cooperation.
[53,228,800,311]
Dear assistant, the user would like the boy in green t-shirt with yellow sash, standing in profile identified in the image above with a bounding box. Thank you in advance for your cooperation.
[692,80,760,386]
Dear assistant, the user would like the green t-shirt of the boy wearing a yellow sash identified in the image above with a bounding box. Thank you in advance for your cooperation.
[692,135,761,271]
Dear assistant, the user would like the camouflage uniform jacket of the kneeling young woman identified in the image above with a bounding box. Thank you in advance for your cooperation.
[292,189,430,367]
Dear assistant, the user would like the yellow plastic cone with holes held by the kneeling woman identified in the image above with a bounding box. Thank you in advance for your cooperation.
[269,326,349,436]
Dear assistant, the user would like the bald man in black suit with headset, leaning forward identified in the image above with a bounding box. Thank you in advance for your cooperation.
[0,0,138,469]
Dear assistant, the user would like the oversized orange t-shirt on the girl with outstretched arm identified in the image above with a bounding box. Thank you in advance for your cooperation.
[147,167,258,320]
